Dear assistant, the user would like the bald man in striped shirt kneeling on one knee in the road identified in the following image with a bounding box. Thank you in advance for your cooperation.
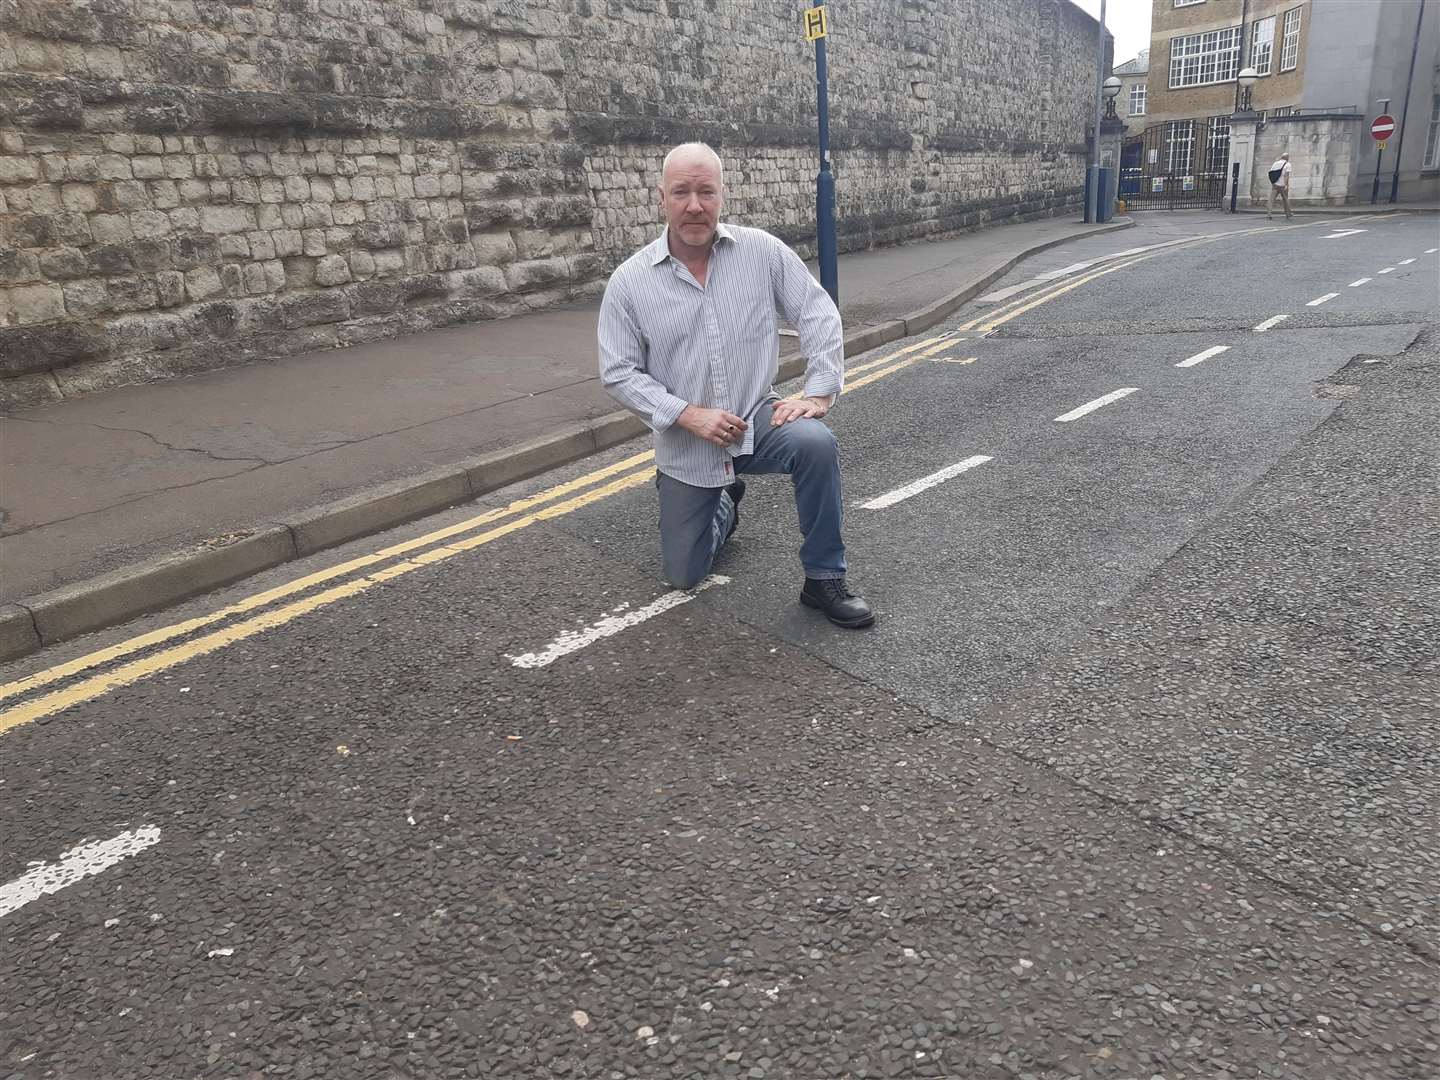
[598,143,876,628]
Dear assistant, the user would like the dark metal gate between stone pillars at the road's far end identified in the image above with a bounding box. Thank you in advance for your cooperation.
[1119,117,1230,210]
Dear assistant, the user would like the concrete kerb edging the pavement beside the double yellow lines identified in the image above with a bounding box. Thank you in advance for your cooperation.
[0,220,1135,661]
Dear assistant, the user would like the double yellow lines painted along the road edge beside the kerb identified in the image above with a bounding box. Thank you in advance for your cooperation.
[0,217,1319,733]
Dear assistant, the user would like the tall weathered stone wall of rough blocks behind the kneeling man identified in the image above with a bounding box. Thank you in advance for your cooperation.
[0,0,1096,403]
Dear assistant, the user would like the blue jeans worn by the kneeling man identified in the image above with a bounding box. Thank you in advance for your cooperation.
[655,405,845,589]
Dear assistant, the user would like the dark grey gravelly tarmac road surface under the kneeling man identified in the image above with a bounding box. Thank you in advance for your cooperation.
[0,215,1440,1080]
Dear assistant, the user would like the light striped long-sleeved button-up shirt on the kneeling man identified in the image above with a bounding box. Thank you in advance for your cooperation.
[599,225,845,488]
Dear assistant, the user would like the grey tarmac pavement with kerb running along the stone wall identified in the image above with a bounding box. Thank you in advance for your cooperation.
[0,217,1132,660]
